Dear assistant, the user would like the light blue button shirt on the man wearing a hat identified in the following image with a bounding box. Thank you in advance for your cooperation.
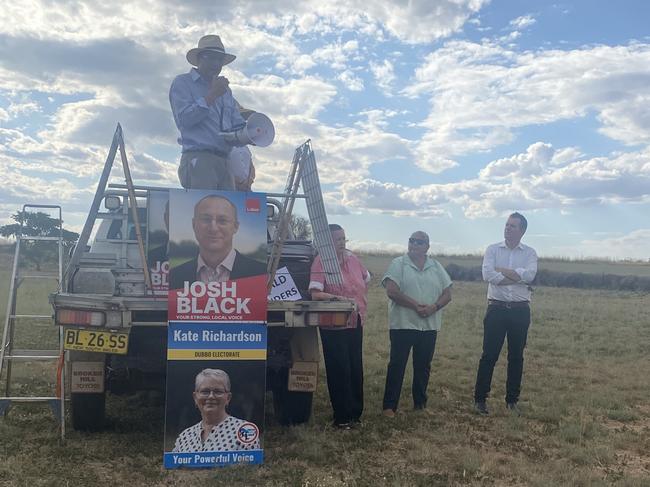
[169,68,246,153]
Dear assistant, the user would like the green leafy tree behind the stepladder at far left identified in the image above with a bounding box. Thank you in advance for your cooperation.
[0,211,79,271]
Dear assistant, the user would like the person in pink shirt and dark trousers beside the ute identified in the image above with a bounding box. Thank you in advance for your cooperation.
[309,224,370,429]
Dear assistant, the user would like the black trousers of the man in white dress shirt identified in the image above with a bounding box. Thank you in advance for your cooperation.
[474,305,530,403]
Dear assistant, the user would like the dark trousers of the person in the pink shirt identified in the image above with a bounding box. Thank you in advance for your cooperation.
[320,325,363,424]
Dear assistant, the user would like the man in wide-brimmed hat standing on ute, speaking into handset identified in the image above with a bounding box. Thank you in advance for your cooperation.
[169,35,246,191]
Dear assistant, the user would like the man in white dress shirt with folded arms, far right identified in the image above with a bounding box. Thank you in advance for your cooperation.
[474,213,537,415]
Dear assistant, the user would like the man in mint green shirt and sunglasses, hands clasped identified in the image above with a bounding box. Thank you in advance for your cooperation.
[382,231,452,417]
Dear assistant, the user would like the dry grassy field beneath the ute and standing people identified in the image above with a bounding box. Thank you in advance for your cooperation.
[0,257,650,487]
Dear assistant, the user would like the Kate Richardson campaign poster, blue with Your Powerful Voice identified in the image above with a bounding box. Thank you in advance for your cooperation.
[164,321,267,469]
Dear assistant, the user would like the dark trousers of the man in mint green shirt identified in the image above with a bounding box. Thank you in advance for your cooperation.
[384,330,438,411]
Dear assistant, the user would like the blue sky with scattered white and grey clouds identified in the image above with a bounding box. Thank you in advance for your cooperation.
[0,0,650,260]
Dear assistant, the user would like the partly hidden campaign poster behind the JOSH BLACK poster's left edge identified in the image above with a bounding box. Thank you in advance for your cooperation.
[147,190,169,296]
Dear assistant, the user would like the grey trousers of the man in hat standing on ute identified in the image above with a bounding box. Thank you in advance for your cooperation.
[178,151,235,191]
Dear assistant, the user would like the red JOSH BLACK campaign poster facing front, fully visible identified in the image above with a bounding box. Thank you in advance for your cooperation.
[168,189,267,323]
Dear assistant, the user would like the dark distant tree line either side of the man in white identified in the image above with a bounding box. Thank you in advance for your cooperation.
[445,263,650,292]
